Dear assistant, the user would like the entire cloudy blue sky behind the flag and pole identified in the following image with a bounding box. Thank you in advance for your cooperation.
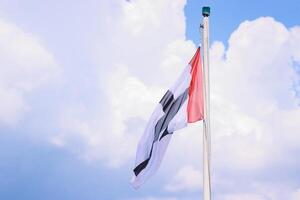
[0,0,300,200]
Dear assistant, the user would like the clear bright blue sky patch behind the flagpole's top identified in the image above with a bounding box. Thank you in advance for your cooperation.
[185,0,299,42]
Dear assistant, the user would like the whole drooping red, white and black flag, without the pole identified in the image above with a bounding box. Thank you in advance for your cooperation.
[131,47,204,188]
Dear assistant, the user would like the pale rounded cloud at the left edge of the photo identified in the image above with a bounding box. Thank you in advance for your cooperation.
[0,19,59,124]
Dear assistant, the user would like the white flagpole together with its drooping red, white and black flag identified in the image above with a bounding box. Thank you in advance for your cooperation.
[131,7,211,200]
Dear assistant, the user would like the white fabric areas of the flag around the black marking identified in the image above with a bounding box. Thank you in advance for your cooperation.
[131,65,191,188]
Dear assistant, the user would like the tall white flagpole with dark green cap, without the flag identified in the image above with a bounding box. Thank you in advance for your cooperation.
[202,7,211,200]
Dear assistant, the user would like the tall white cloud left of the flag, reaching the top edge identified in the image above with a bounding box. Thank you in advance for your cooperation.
[51,0,195,167]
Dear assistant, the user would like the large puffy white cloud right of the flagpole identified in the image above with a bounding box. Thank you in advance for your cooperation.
[211,18,300,170]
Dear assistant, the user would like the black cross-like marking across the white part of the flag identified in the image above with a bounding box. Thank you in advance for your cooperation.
[133,88,189,176]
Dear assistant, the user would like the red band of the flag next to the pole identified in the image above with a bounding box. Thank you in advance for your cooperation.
[187,47,204,123]
